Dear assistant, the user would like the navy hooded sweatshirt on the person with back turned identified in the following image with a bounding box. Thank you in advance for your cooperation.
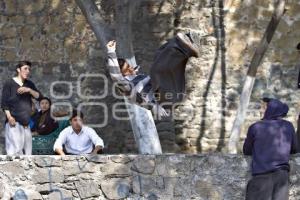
[243,99,297,175]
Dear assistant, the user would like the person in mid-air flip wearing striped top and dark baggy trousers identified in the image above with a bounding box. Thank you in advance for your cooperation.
[106,33,198,116]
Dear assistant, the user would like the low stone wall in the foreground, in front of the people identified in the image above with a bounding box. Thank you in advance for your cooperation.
[0,154,300,200]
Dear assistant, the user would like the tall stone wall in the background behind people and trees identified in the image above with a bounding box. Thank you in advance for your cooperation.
[0,0,300,153]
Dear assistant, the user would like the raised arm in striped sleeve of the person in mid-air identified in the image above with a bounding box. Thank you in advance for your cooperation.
[106,40,131,92]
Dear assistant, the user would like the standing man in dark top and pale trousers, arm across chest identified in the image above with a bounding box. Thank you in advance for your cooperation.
[1,61,41,155]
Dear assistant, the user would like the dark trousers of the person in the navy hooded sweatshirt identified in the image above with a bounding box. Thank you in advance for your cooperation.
[246,170,289,200]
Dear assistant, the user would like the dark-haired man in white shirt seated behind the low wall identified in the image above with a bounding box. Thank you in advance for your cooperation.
[53,110,104,155]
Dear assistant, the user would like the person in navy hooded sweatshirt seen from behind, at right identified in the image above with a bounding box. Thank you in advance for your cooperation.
[243,99,297,200]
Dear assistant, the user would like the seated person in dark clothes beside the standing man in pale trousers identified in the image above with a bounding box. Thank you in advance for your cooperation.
[30,97,67,135]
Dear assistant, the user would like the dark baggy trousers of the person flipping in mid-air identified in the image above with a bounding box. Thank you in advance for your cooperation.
[150,37,192,102]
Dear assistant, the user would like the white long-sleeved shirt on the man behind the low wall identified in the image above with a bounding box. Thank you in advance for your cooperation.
[53,126,104,155]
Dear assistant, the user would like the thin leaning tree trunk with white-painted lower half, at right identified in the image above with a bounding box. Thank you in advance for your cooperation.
[228,0,286,154]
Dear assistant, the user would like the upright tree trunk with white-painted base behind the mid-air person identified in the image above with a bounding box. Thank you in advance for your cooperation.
[116,0,162,154]
